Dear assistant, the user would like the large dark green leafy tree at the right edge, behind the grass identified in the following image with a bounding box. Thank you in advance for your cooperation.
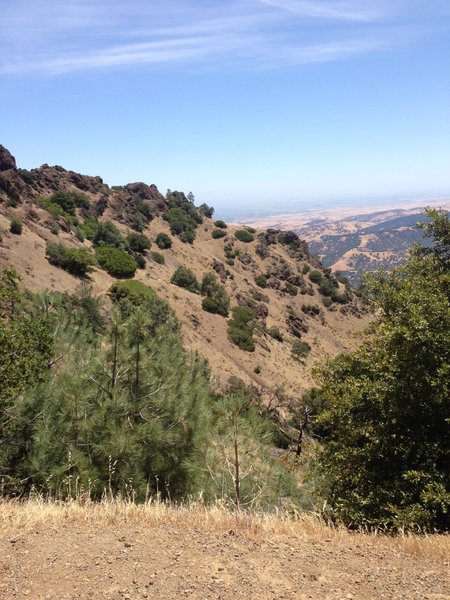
[317,211,450,530]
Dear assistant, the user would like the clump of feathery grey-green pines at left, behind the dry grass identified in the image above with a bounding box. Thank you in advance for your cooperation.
[0,271,295,507]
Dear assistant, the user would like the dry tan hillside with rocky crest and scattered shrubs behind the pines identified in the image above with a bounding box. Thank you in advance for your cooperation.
[0,147,368,397]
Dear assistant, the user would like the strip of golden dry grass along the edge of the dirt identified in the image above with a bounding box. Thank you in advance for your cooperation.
[0,499,450,564]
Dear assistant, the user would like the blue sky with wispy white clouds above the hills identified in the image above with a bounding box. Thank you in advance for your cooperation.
[0,0,450,212]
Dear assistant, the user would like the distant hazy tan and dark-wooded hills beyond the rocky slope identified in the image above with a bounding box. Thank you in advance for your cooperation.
[237,199,449,285]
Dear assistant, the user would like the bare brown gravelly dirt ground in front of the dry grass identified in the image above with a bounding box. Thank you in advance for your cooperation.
[0,502,450,600]
